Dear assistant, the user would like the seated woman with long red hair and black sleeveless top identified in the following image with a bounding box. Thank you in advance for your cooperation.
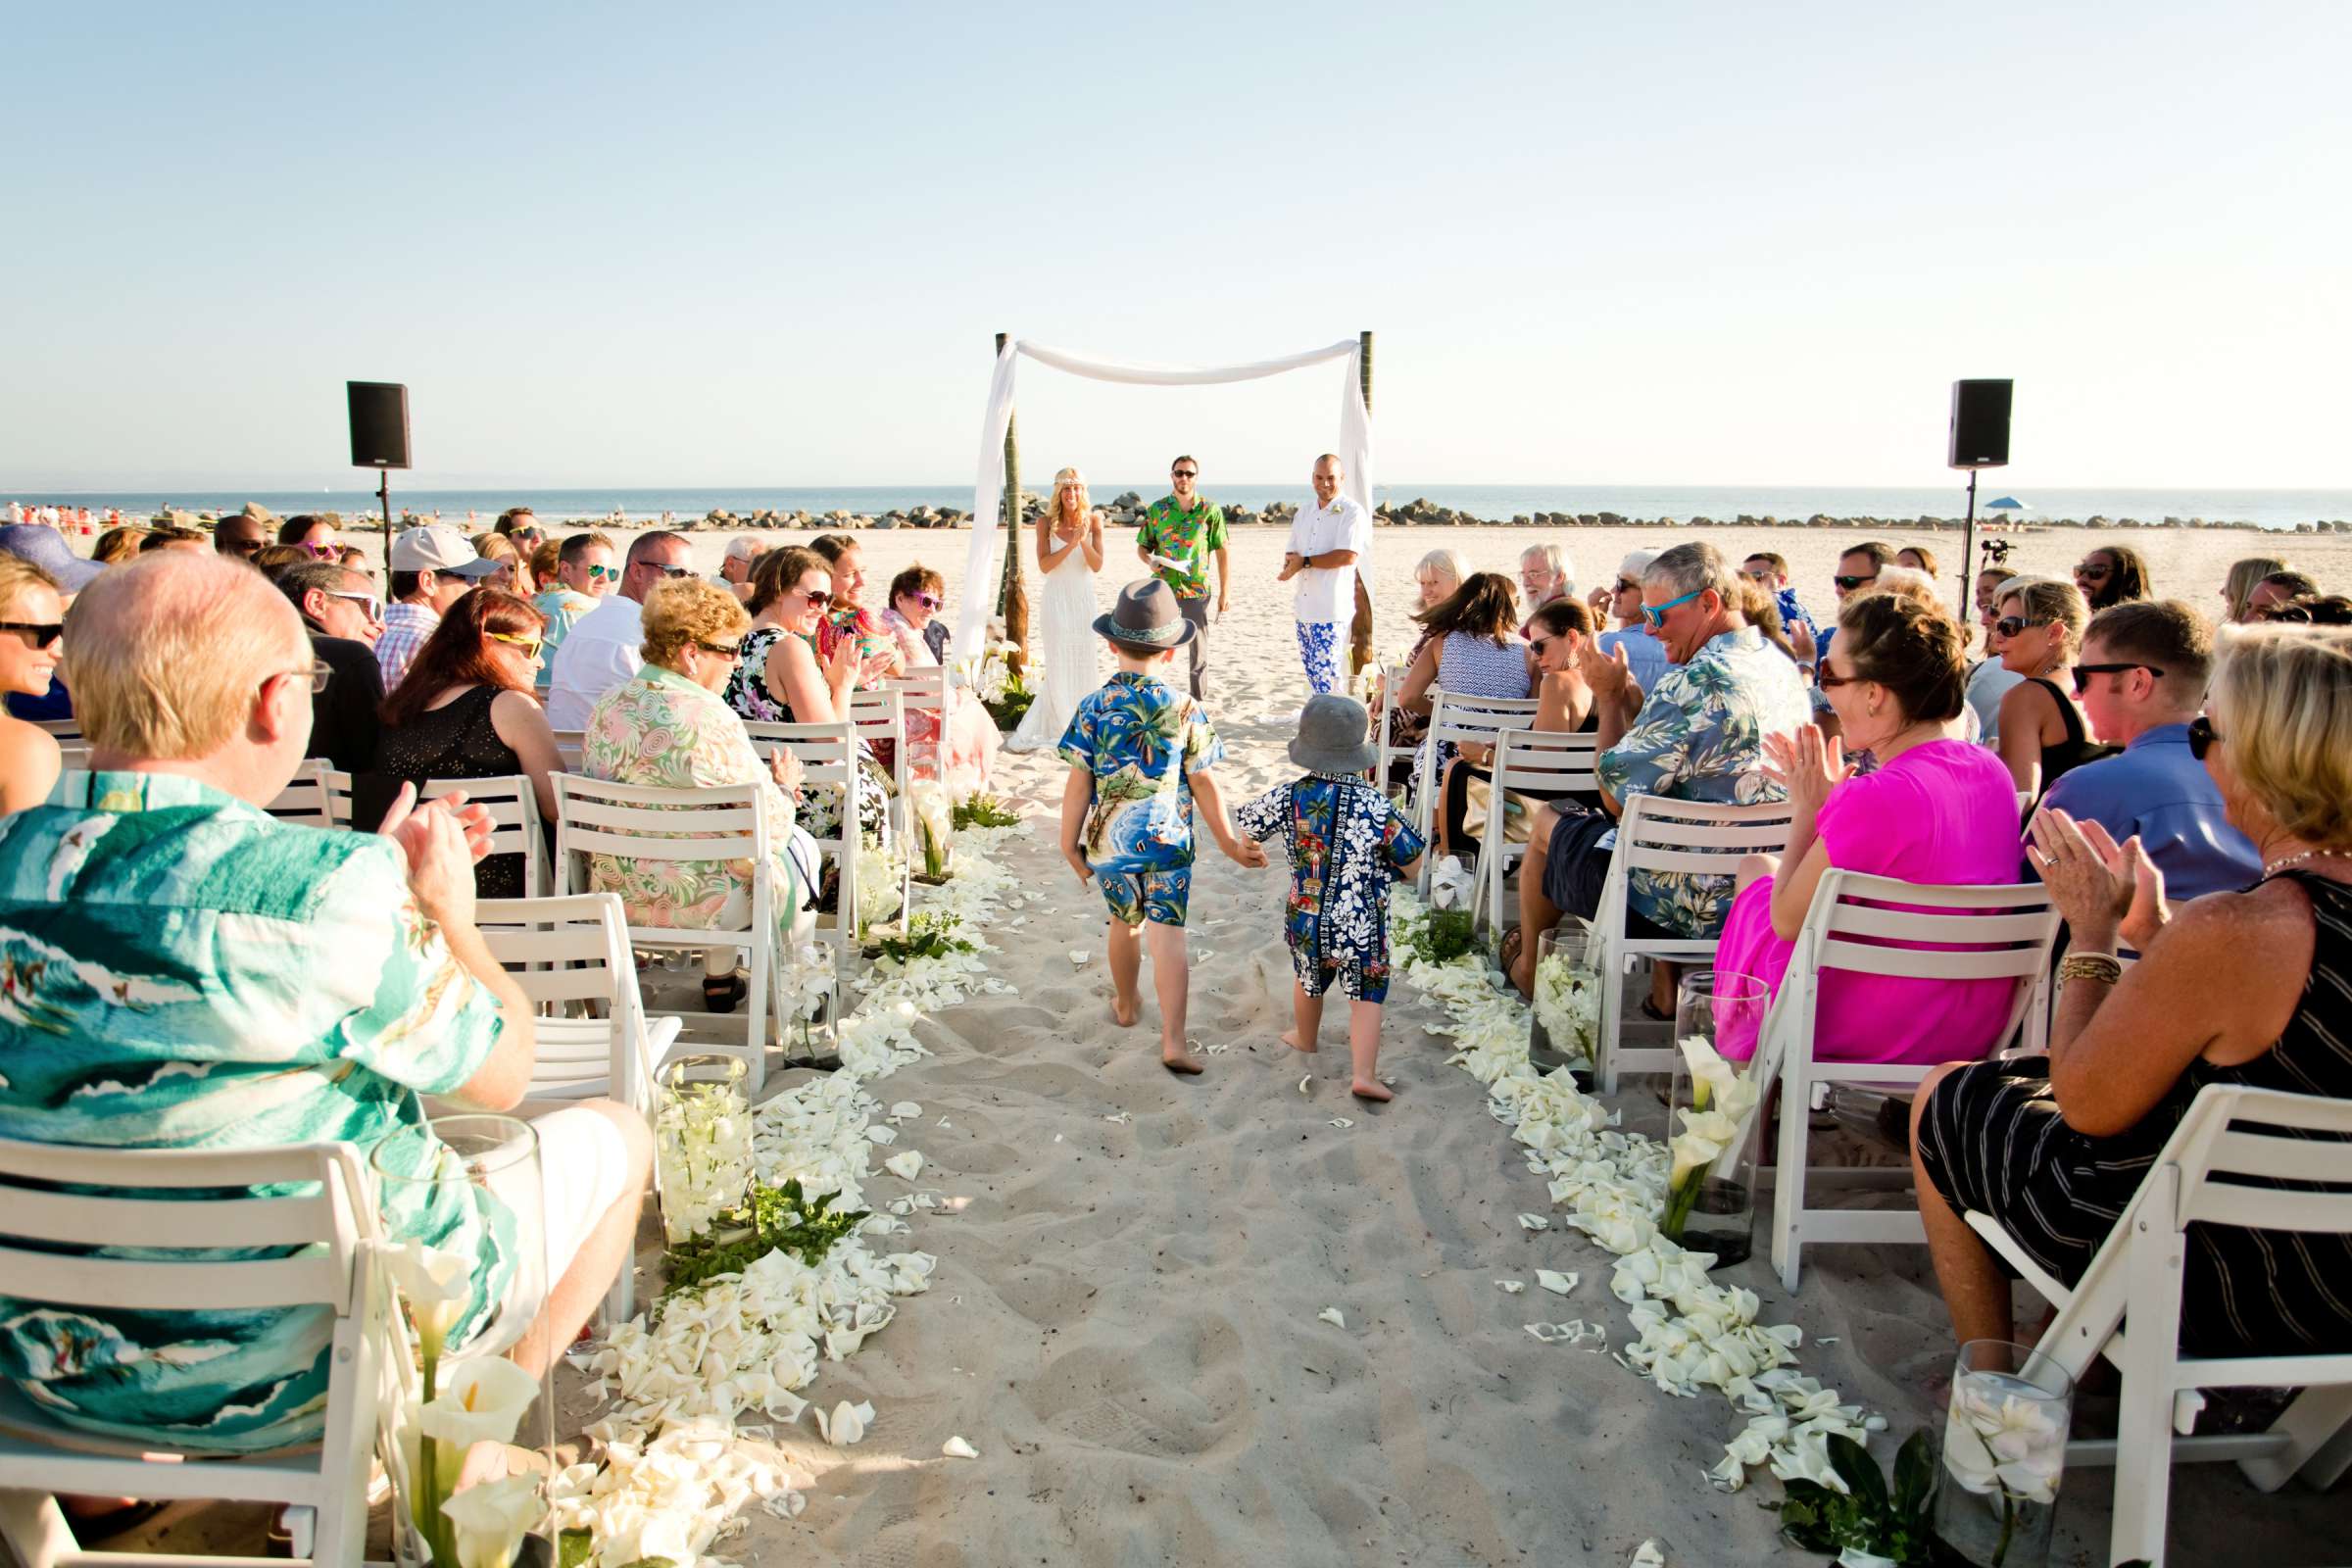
[373,587,564,898]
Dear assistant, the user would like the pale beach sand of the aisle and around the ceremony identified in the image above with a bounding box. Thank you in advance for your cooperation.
[667,529,2352,1568]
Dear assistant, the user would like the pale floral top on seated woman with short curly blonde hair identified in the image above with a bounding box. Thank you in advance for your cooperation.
[581,665,818,938]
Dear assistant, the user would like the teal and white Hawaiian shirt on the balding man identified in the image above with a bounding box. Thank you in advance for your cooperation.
[0,773,515,1452]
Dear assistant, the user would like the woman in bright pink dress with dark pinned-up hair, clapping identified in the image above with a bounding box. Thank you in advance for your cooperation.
[1715,592,2018,1065]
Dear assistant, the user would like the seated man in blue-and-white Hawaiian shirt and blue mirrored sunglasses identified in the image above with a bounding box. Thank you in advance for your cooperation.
[1503,543,1811,1013]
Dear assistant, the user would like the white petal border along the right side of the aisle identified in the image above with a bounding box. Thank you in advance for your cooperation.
[1390,886,1886,1491]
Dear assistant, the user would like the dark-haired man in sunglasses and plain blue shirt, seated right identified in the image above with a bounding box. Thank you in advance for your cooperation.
[2028,600,2263,898]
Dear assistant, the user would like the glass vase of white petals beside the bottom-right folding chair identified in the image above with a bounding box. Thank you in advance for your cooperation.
[1936,1340,2075,1568]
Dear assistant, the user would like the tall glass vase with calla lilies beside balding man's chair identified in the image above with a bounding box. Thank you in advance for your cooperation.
[367,1114,560,1566]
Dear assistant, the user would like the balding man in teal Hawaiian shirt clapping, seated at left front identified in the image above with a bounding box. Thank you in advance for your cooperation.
[0,550,652,1452]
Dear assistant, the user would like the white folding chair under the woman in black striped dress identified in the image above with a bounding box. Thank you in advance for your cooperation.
[1966,1084,2352,1568]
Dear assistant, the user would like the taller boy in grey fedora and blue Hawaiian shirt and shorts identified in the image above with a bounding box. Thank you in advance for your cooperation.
[1058,578,1265,1072]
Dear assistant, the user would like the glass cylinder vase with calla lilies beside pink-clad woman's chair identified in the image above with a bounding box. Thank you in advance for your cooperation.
[1658,968,1771,1265]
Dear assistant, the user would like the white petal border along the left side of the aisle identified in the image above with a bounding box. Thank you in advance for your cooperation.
[555,823,1028,1568]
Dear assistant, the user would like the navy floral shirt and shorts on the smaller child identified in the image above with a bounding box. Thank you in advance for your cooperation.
[1233,773,1423,1002]
